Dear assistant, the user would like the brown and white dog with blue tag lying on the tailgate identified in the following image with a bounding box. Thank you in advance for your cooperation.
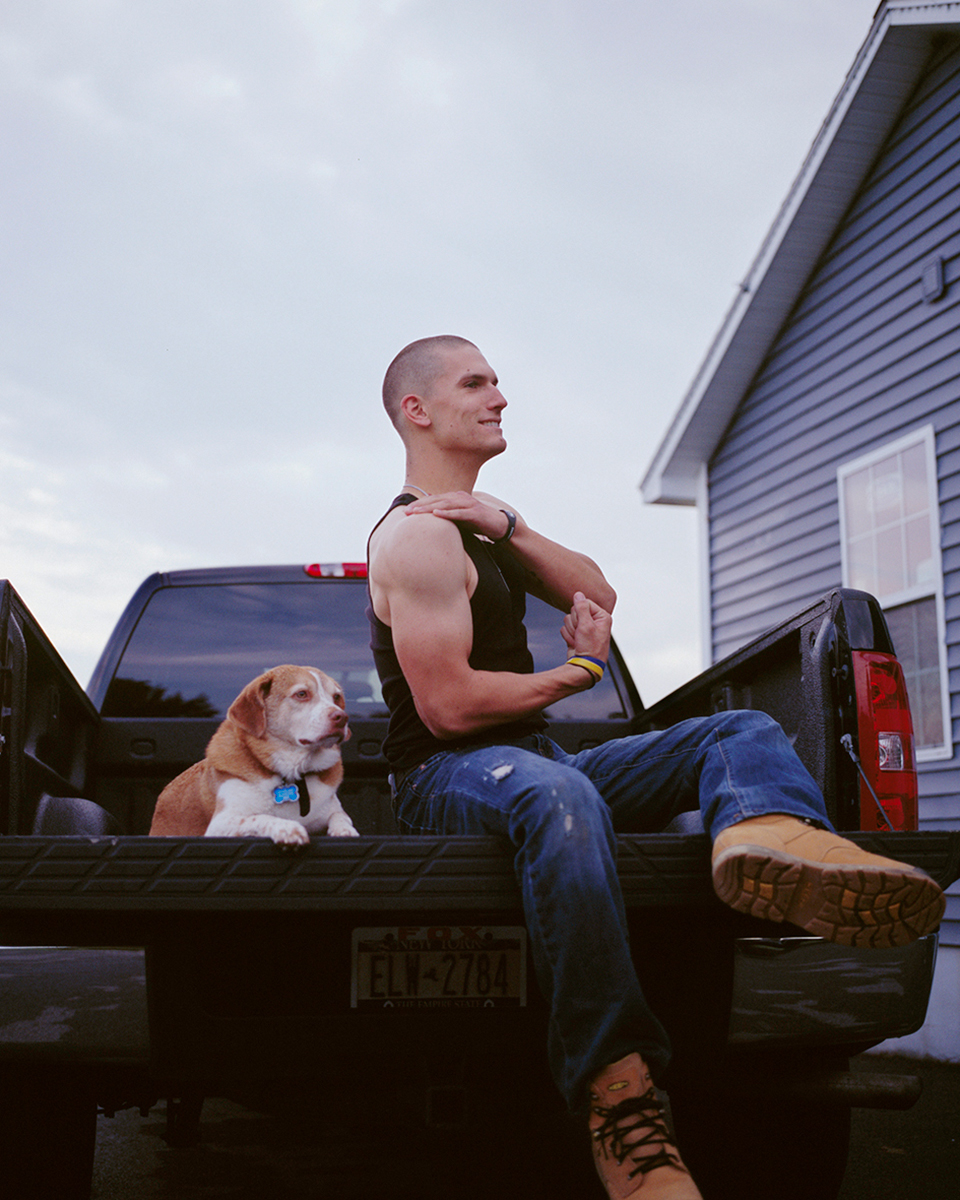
[150,665,358,846]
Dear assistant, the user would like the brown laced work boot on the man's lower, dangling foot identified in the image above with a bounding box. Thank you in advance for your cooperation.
[590,1054,703,1200]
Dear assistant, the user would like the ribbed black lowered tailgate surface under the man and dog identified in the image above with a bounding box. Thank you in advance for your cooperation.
[0,830,960,944]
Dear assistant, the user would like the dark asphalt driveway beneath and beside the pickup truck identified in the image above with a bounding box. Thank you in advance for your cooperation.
[94,1055,960,1200]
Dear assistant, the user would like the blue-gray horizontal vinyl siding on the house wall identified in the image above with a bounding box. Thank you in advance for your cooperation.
[708,32,960,946]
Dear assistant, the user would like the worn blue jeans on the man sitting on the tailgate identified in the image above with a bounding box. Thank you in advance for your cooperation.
[396,712,829,1109]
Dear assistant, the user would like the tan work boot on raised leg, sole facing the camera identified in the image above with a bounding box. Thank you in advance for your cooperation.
[713,814,946,948]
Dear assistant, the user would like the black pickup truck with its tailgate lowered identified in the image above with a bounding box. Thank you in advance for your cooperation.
[0,564,960,1200]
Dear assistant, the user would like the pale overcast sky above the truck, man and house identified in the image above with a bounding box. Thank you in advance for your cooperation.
[0,0,876,702]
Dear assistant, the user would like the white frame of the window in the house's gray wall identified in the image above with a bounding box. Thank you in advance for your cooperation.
[836,425,953,762]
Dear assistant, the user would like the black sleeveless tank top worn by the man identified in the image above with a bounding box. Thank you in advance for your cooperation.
[367,493,547,770]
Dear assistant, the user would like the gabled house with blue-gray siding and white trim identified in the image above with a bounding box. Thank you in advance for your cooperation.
[642,0,960,1061]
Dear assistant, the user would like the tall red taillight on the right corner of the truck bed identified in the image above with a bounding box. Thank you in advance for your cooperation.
[852,650,918,830]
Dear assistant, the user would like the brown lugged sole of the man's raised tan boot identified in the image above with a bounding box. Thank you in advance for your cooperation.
[713,845,946,949]
